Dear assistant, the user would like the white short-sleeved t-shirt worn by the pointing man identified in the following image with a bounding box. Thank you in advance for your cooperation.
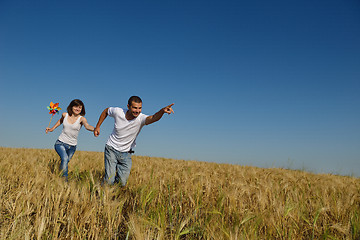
[106,107,148,152]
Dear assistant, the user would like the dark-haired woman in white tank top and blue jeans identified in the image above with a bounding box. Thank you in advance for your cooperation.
[45,99,94,181]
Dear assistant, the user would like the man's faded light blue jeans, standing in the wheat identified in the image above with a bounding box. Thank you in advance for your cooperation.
[104,145,132,186]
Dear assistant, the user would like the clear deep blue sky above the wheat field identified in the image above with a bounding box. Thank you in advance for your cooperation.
[0,0,360,176]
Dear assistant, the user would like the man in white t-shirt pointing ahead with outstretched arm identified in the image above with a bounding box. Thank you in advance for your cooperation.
[94,96,174,186]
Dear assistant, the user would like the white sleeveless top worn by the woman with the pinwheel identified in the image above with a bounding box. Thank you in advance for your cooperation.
[58,113,82,146]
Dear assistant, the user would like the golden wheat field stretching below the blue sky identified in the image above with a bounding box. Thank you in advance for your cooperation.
[0,147,360,240]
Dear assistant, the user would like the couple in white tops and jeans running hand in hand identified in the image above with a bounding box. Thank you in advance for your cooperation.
[46,96,174,186]
